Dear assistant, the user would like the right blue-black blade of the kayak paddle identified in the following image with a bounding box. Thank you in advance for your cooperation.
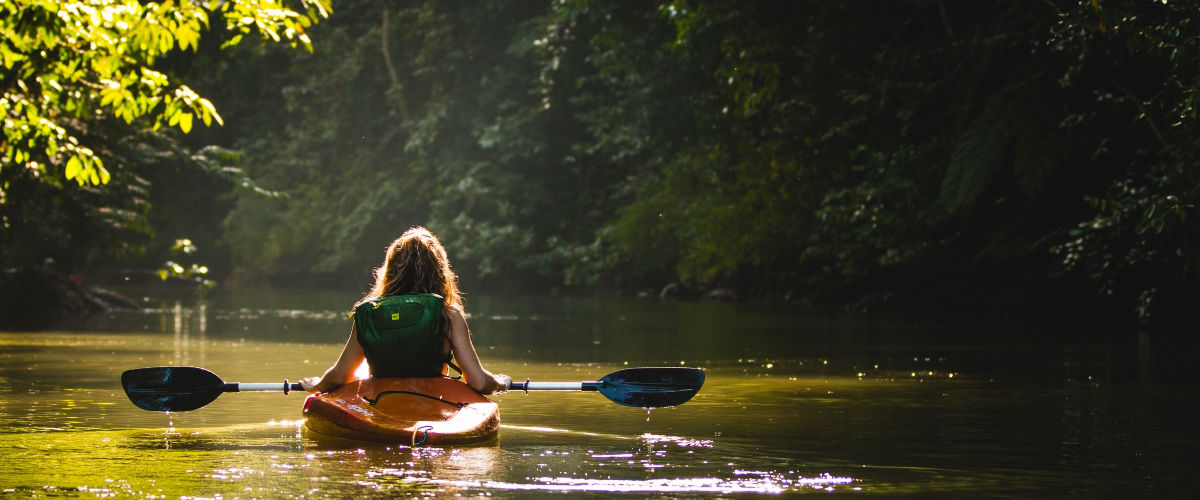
[596,367,704,408]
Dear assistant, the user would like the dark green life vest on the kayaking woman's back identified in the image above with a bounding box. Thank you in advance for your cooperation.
[354,294,450,376]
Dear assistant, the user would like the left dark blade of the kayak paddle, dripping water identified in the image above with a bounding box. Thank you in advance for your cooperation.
[121,367,224,411]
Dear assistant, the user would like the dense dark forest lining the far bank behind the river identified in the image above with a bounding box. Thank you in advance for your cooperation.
[0,0,1200,325]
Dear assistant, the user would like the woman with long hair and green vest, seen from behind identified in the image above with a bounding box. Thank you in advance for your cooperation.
[300,227,512,394]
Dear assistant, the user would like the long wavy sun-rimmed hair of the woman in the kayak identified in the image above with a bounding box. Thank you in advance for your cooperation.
[355,227,462,315]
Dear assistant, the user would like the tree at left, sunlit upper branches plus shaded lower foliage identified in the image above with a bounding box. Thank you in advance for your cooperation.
[0,0,329,276]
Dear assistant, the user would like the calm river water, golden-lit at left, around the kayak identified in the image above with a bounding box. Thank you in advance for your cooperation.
[0,286,1200,498]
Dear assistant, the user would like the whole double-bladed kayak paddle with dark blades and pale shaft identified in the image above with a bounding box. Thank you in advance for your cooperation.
[121,367,704,411]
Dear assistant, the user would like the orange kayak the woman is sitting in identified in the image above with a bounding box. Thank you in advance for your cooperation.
[304,378,500,446]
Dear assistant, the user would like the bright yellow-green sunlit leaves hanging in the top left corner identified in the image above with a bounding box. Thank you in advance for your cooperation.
[0,0,329,185]
